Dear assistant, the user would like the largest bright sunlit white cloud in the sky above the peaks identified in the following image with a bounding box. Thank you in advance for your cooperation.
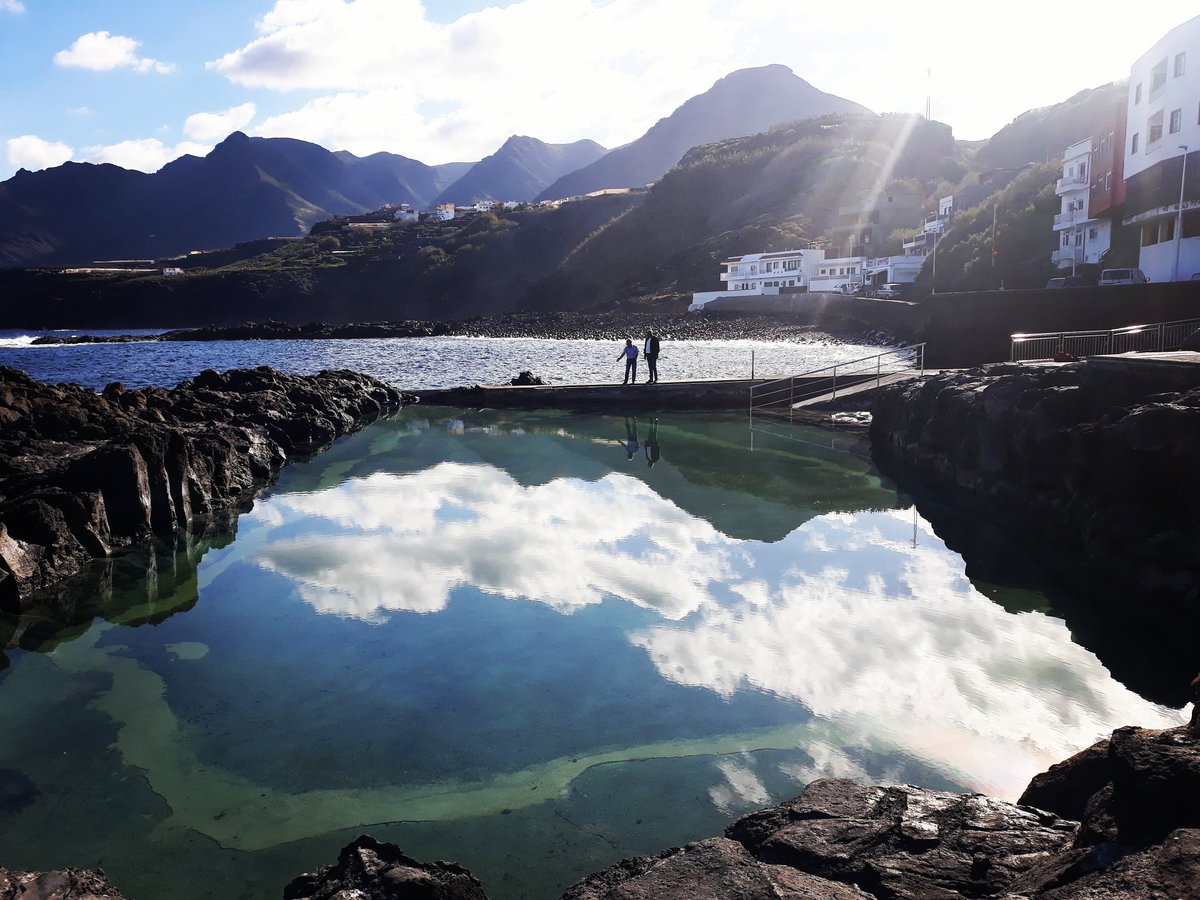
[201,0,1195,163]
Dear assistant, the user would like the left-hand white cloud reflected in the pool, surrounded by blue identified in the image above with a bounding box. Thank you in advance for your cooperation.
[254,463,728,620]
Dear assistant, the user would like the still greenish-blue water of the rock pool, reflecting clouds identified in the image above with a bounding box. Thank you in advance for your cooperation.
[0,410,1184,900]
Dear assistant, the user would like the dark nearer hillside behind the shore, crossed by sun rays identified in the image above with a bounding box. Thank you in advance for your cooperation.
[0,85,1118,326]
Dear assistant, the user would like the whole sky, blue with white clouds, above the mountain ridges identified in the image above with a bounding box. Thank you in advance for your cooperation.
[0,0,1193,180]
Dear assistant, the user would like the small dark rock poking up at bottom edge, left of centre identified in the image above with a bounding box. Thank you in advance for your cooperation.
[283,834,487,900]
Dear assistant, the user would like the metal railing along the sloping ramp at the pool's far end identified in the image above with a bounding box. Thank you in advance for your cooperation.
[750,343,925,415]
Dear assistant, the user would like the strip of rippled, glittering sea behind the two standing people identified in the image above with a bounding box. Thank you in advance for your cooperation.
[0,331,881,390]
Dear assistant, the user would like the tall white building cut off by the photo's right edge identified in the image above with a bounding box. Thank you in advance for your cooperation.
[1122,16,1200,281]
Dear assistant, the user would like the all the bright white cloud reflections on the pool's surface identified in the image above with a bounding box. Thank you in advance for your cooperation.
[248,463,1183,803]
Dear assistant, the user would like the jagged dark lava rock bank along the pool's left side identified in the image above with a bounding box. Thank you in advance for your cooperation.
[0,367,413,613]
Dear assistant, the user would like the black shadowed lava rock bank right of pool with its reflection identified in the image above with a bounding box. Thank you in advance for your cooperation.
[870,359,1200,706]
